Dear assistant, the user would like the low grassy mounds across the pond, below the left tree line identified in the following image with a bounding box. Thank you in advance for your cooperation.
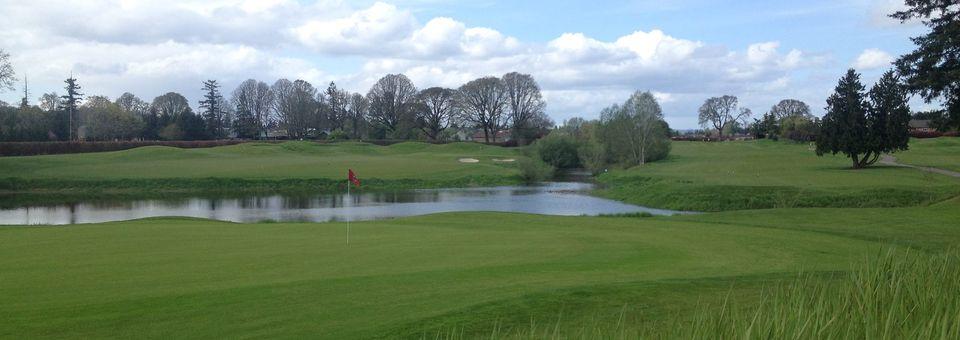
[0,142,520,196]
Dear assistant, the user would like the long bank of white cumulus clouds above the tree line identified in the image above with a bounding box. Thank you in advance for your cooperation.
[0,0,828,126]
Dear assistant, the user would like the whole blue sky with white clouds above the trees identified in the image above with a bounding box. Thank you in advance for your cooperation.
[0,0,930,129]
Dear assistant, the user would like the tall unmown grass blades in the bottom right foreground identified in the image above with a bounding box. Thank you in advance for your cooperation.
[421,250,960,339]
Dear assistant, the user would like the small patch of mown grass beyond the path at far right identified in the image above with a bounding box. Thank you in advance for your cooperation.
[894,137,960,172]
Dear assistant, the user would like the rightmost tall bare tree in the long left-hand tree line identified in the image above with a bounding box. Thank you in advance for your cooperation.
[502,72,546,143]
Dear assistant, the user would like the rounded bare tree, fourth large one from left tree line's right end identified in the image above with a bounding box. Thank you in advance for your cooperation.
[367,74,417,132]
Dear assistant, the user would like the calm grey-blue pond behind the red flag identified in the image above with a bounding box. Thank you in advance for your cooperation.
[0,182,686,225]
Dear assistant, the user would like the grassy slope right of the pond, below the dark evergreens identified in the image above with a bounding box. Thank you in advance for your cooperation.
[599,140,960,211]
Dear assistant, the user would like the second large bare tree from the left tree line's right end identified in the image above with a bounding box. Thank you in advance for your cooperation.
[457,77,509,143]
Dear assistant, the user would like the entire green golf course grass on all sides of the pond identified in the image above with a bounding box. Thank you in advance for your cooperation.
[0,138,960,339]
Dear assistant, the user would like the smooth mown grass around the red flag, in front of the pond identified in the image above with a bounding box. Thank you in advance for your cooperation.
[0,201,960,338]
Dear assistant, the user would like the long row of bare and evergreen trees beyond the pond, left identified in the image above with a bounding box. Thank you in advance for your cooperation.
[0,66,554,143]
